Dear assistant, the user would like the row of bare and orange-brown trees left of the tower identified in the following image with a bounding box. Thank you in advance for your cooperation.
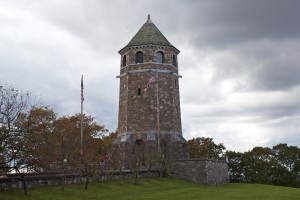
[0,85,115,193]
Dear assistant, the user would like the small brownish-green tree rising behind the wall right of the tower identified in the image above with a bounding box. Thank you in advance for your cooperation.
[188,137,225,159]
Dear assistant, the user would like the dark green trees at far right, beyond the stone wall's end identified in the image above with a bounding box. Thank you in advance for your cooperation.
[226,144,300,187]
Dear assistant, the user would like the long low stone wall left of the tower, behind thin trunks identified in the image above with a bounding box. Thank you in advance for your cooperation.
[0,171,159,191]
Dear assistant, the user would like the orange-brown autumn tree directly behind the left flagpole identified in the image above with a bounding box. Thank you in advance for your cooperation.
[54,114,107,189]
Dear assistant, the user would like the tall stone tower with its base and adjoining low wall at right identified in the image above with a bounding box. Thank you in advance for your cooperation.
[112,15,229,184]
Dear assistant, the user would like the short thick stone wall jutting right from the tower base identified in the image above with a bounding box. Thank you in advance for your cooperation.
[172,159,229,185]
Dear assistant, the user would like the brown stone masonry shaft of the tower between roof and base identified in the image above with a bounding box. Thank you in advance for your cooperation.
[118,46,182,138]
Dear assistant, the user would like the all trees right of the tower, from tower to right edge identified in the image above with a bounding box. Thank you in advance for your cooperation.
[188,137,300,187]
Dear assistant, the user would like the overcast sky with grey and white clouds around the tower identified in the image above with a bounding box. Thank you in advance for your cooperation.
[0,0,300,152]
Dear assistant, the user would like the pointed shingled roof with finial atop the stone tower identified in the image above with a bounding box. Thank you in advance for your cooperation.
[120,15,178,51]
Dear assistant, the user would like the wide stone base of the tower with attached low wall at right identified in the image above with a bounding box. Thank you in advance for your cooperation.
[112,133,229,185]
